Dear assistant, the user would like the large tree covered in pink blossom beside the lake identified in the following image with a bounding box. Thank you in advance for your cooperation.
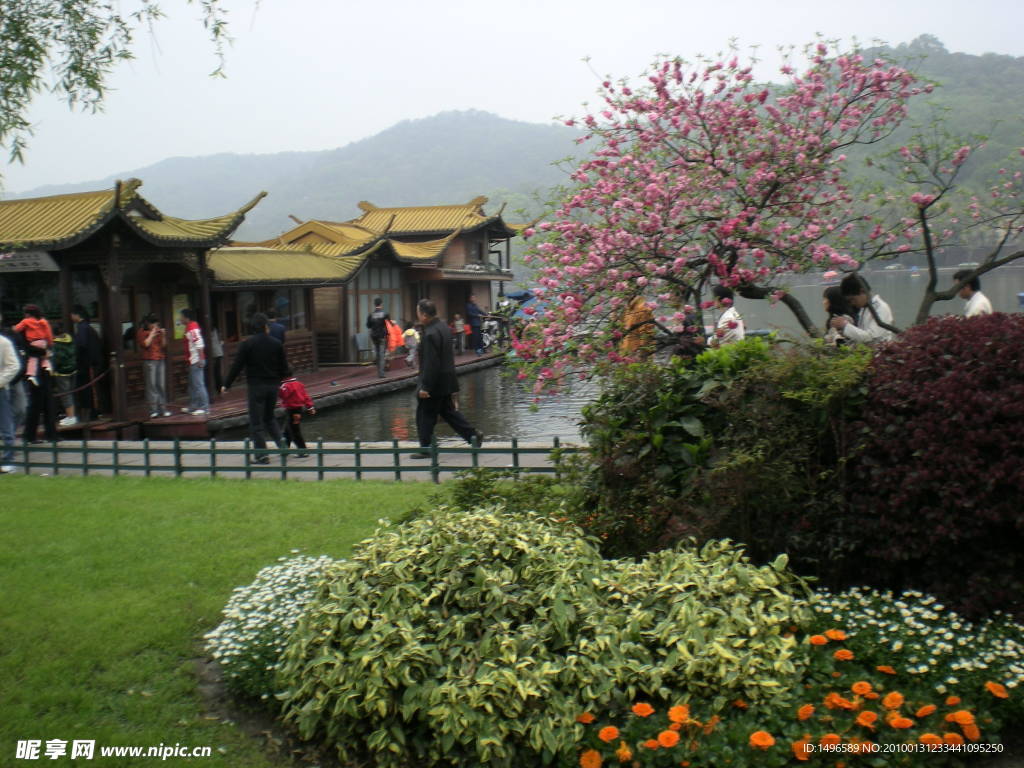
[517,42,928,390]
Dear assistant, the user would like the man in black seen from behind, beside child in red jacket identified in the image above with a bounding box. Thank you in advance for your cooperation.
[220,312,288,464]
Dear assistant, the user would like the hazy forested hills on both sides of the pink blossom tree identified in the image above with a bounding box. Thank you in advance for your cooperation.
[9,35,1024,240]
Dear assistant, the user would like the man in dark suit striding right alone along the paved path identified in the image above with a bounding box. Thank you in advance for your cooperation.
[410,299,483,459]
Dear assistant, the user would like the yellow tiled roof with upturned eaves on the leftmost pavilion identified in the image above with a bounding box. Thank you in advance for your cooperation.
[0,179,266,250]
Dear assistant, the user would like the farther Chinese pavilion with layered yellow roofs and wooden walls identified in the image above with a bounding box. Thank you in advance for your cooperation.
[209,198,517,364]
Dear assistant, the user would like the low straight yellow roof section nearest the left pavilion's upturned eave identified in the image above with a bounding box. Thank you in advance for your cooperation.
[207,246,368,286]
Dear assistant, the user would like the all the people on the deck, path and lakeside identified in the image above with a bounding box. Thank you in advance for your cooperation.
[0,270,992,473]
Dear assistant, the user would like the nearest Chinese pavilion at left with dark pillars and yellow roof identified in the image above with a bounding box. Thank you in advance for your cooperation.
[0,179,264,420]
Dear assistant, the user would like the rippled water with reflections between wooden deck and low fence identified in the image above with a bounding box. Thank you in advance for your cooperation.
[288,367,593,443]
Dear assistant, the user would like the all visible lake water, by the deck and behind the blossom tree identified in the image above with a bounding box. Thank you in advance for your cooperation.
[238,267,1024,442]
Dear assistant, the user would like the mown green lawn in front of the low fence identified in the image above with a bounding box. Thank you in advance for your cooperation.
[0,476,435,768]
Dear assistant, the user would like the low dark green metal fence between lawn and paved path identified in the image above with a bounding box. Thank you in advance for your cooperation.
[20,437,585,482]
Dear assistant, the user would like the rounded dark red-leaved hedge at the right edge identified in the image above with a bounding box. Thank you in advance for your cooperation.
[851,314,1024,614]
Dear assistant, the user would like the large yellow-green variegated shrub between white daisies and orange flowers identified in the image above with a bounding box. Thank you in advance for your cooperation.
[279,507,807,766]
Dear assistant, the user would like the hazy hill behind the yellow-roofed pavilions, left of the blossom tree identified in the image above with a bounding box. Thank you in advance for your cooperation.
[18,111,580,240]
